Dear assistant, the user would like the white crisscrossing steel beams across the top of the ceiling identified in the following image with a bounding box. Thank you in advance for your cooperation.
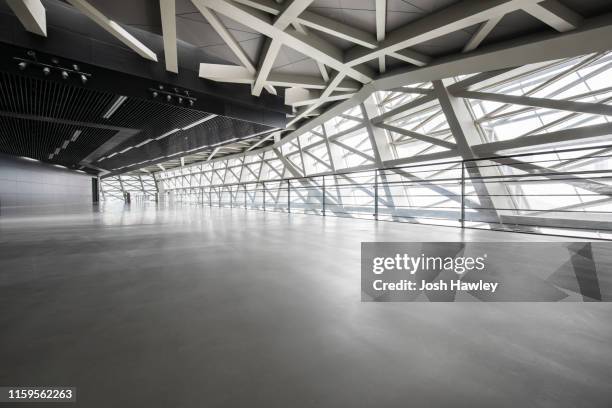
[16,0,612,126]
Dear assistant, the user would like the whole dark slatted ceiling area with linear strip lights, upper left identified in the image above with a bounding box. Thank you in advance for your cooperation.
[0,67,269,171]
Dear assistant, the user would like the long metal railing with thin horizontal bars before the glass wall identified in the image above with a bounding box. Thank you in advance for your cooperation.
[161,146,612,239]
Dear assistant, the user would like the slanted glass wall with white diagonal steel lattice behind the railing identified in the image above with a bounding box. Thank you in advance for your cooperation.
[141,53,612,239]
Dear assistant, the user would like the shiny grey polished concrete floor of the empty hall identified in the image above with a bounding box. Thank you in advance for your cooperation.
[0,205,612,408]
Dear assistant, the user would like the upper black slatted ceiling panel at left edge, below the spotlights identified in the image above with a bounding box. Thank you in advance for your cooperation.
[0,72,114,122]
